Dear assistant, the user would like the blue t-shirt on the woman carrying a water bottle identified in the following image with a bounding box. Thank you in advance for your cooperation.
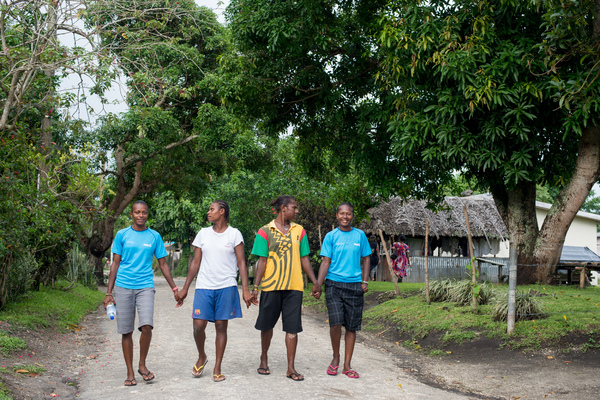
[112,226,167,289]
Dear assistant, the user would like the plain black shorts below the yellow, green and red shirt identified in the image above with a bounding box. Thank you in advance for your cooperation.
[254,290,303,333]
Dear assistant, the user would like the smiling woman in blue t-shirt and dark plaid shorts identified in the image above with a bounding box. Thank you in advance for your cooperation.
[318,203,371,378]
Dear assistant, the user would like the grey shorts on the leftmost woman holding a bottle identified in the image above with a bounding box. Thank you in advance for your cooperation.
[113,286,156,335]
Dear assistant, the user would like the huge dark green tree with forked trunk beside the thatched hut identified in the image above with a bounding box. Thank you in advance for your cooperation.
[228,0,600,283]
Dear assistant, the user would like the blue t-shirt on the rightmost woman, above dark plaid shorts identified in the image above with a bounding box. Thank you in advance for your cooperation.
[321,228,371,282]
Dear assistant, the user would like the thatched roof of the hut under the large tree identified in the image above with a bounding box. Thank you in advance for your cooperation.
[361,195,508,239]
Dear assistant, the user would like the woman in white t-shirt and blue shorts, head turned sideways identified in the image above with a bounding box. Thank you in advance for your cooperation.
[179,200,252,382]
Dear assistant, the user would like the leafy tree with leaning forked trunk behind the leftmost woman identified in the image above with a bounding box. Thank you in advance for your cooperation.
[68,0,260,280]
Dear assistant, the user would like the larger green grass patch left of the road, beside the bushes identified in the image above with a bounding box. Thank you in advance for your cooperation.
[0,281,104,330]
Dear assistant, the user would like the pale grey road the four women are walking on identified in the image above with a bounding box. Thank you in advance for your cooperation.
[73,279,479,400]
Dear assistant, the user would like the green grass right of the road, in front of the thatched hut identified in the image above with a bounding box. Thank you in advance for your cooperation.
[304,282,600,351]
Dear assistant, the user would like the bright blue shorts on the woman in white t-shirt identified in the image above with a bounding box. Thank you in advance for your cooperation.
[192,286,242,322]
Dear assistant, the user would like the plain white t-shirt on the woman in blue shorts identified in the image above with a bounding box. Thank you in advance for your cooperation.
[192,226,244,289]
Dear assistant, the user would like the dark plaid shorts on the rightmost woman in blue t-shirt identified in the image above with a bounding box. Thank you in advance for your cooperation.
[325,279,365,331]
